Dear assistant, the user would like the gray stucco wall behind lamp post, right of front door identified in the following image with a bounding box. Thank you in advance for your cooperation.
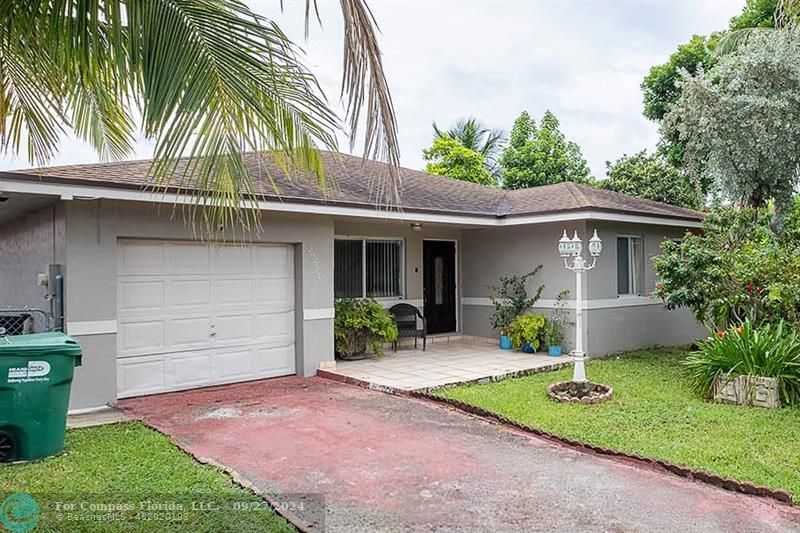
[462,221,705,355]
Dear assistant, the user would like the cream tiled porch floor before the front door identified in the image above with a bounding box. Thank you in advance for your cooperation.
[327,342,572,390]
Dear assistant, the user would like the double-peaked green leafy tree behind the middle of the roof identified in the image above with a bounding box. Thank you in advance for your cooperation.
[500,111,592,189]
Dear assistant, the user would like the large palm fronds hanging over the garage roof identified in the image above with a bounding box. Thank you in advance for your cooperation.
[0,0,399,231]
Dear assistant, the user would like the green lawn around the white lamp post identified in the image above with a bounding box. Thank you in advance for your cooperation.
[437,349,800,500]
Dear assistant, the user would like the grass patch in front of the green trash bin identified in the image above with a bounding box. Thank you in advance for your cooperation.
[0,422,295,533]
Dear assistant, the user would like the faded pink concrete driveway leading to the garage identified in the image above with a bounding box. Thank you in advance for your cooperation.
[120,377,800,533]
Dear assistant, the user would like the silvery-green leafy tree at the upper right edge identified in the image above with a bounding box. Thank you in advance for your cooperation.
[663,30,800,214]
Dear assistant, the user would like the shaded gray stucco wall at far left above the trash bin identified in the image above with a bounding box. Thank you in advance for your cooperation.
[0,203,64,311]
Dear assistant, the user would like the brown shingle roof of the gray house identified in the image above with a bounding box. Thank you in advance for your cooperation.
[0,152,702,220]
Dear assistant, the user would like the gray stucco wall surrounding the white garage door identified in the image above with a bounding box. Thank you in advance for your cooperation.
[65,200,333,409]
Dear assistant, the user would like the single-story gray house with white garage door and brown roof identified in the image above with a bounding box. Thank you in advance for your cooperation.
[0,153,701,409]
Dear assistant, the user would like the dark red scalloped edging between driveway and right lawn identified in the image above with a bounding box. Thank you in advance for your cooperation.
[317,363,794,505]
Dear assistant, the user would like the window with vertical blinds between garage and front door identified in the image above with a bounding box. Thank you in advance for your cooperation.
[333,239,405,298]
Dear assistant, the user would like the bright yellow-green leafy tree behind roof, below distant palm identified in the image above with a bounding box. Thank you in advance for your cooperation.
[422,137,497,186]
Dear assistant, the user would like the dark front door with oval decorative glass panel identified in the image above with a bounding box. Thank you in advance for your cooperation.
[422,241,456,333]
